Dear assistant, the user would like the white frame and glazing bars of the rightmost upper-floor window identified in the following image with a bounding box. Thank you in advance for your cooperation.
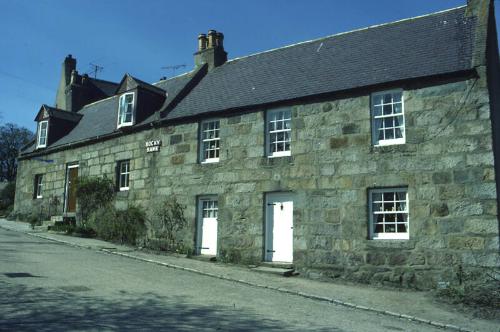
[370,89,406,146]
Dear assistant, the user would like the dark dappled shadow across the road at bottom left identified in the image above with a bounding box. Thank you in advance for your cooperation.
[0,280,332,332]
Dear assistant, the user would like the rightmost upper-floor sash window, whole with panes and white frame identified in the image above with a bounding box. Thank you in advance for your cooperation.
[371,90,405,145]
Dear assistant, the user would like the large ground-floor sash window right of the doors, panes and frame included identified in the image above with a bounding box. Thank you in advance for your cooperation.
[369,188,409,239]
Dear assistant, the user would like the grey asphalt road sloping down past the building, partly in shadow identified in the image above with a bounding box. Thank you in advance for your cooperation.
[0,229,442,332]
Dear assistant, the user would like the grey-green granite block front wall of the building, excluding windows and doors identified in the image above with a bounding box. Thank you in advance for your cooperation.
[15,79,499,288]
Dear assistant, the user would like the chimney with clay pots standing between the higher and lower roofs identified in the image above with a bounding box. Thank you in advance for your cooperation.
[194,30,227,71]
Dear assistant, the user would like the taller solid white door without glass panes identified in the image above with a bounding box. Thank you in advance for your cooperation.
[265,193,293,263]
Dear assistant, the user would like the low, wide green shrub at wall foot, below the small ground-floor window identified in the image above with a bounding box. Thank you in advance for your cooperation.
[89,205,146,245]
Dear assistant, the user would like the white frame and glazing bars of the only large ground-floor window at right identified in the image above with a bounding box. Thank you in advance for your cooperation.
[368,187,410,240]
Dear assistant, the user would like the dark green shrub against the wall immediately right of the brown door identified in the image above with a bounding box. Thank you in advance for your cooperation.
[76,176,115,227]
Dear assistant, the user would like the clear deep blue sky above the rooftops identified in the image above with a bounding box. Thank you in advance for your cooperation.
[0,0,499,130]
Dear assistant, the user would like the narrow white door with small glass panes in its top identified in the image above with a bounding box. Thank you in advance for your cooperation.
[198,198,219,256]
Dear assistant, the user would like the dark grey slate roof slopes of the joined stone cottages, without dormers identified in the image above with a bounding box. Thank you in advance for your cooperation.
[23,6,476,154]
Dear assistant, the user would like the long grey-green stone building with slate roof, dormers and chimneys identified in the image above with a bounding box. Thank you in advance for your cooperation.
[15,0,500,288]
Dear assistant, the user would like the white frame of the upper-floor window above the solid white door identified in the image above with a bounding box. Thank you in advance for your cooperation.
[266,107,292,158]
